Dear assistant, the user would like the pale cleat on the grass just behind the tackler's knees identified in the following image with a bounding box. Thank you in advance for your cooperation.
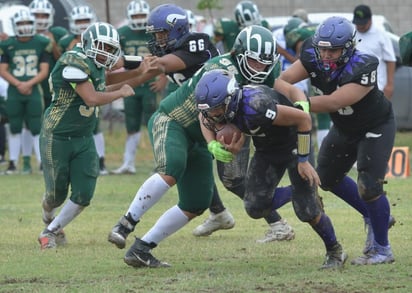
[192,210,235,236]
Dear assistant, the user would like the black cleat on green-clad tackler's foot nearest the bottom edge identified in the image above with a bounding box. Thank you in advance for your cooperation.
[124,237,170,268]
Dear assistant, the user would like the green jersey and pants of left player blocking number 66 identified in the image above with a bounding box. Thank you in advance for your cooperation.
[40,47,105,207]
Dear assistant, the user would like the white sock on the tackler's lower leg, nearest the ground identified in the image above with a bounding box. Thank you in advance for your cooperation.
[142,205,189,244]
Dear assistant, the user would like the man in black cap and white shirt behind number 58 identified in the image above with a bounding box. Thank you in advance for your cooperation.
[352,5,396,99]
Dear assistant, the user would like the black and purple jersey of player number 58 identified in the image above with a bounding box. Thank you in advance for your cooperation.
[300,39,392,134]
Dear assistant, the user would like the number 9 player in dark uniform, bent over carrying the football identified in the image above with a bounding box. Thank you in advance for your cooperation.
[195,70,347,269]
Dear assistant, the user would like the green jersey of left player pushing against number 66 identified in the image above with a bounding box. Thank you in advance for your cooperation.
[43,47,106,137]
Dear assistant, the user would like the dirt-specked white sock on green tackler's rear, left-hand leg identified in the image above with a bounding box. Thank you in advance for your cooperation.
[126,173,170,222]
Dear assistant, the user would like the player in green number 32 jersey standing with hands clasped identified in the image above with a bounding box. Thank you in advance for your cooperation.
[0,7,52,174]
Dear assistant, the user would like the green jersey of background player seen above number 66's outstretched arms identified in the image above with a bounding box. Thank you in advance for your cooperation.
[117,25,153,88]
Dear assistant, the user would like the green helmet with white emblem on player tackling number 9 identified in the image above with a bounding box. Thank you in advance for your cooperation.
[231,25,279,83]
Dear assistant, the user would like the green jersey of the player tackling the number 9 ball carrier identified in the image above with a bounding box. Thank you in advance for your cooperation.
[159,53,280,141]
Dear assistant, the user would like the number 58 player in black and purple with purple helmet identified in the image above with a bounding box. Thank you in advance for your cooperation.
[280,17,396,265]
